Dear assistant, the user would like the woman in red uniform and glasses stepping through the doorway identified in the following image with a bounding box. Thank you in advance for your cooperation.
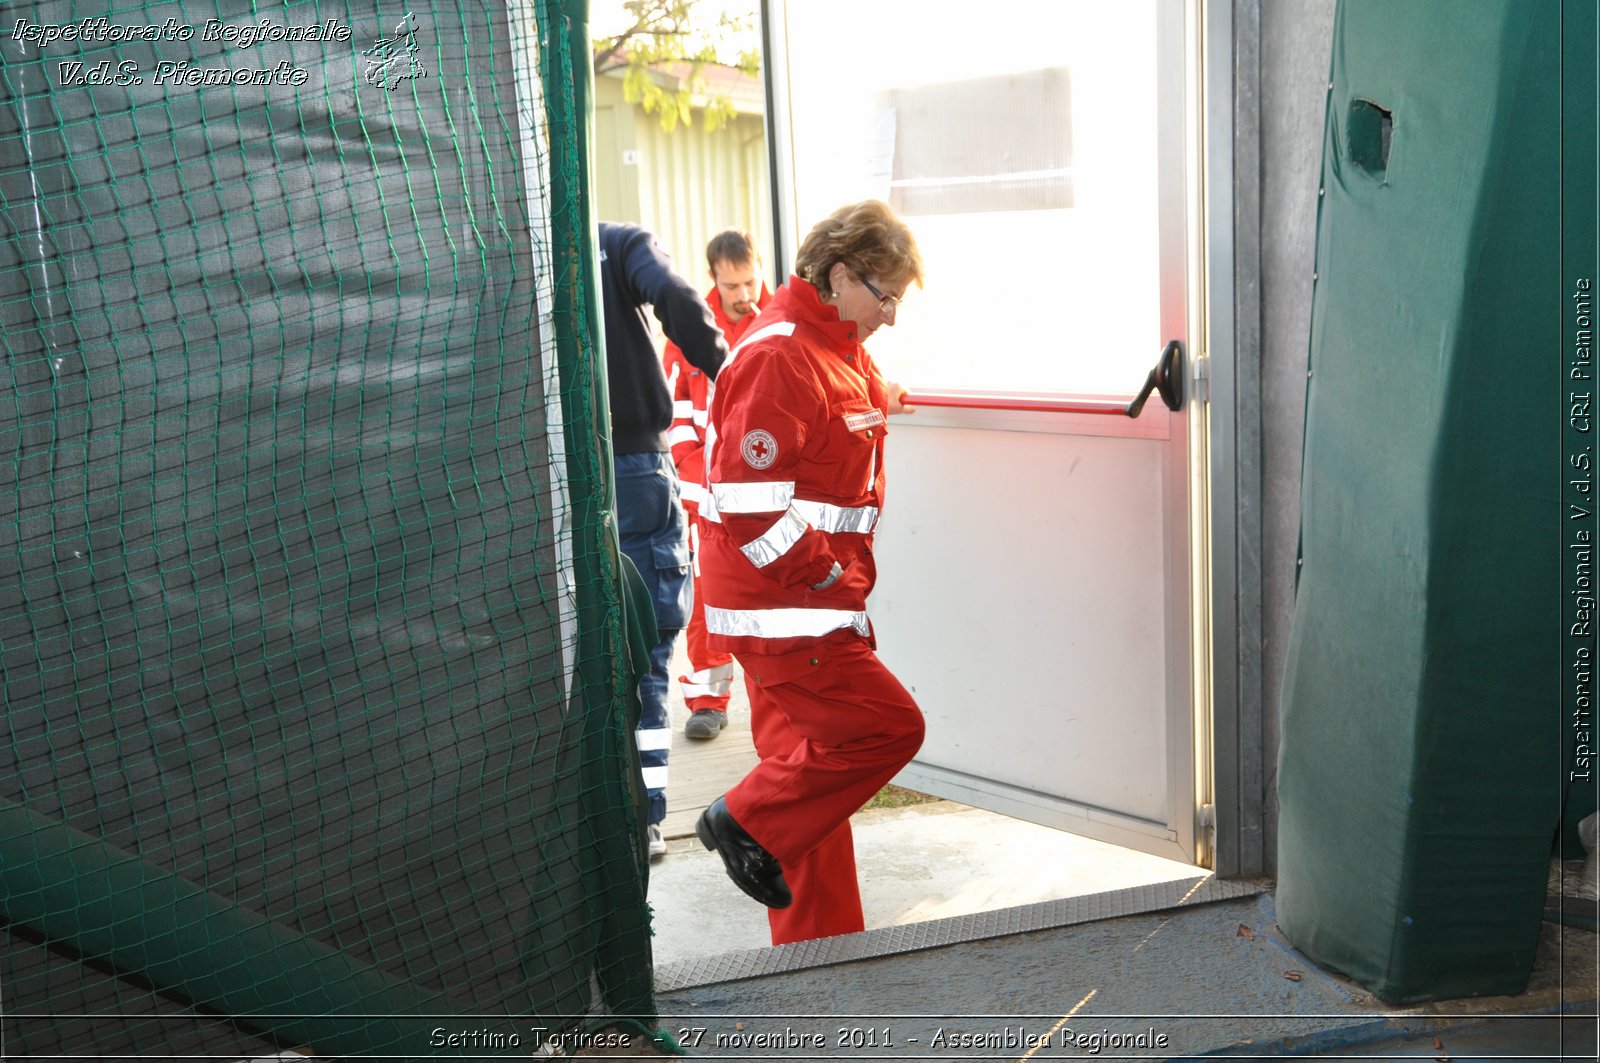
[696,200,923,945]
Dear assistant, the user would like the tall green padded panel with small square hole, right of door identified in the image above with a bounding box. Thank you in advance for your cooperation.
[1277,0,1563,1002]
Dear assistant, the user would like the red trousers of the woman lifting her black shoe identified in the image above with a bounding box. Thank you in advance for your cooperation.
[726,640,923,945]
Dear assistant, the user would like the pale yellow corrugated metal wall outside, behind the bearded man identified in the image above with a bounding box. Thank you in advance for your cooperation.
[594,77,779,288]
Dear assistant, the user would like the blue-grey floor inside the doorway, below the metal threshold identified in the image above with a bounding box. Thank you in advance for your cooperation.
[658,893,1600,1063]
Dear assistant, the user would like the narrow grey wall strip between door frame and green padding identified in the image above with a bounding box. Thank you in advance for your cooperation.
[1259,0,1336,874]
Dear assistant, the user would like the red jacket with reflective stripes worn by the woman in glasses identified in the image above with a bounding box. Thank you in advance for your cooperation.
[701,277,888,653]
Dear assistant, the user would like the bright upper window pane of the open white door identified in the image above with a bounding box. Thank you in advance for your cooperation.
[784,0,1165,395]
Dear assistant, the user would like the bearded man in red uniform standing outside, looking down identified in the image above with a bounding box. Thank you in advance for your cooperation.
[662,229,773,738]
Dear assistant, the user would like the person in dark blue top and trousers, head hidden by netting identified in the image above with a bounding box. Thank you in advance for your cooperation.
[600,221,728,860]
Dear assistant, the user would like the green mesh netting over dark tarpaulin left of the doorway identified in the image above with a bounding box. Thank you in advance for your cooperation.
[0,0,653,1058]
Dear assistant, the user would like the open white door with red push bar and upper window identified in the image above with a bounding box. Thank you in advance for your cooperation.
[768,0,1210,863]
